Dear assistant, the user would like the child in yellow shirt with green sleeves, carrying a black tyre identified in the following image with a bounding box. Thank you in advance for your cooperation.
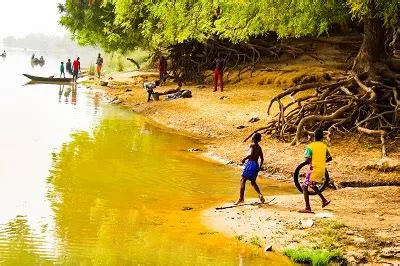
[299,129,332,213]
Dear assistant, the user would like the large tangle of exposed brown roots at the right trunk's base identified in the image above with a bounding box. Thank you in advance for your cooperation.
[246,68,400,157]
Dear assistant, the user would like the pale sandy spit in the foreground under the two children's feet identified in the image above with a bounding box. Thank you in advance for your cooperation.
[203,187,400,263]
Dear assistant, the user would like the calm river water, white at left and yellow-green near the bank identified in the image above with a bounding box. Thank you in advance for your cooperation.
[0,51,290,265]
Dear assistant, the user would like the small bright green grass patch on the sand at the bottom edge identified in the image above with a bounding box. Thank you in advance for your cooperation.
[283,247,346,266]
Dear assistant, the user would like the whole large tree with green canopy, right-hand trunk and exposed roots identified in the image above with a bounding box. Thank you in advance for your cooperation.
[60,0,400,155]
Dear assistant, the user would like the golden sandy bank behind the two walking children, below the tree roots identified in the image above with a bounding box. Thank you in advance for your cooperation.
[98,65,400,186]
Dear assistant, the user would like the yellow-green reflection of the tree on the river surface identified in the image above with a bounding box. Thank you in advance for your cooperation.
[43,113,288,265]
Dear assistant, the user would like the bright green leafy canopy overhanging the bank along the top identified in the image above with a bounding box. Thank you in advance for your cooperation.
[59,0,400,52]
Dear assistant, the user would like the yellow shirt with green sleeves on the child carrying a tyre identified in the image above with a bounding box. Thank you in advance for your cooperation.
[305,141,331,182]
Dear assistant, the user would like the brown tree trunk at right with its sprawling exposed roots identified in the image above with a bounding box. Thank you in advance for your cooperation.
[247,0,400,156]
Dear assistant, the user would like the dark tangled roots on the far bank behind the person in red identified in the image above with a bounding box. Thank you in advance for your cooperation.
[168,36,322,82]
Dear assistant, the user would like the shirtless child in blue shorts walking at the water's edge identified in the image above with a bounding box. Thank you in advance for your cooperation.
[235,133,265,205]
